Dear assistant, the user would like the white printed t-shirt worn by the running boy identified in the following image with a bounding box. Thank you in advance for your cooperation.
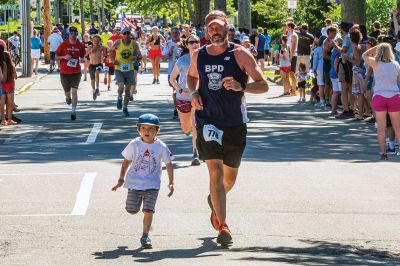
[122,137,173,190]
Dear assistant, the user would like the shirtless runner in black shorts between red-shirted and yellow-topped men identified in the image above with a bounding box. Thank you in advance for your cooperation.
[85,34,105,100]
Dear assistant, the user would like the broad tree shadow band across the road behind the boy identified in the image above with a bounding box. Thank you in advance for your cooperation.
[0,93,392,163]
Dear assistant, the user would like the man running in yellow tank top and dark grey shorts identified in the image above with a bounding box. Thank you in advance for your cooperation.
[110,28,142,116]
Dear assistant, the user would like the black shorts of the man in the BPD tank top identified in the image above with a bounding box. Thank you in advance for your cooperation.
[196,124,247,168]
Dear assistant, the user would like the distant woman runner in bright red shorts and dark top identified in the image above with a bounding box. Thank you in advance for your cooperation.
[146,26,166,84]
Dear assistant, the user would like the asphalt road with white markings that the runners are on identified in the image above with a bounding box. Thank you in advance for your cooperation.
[0,64,400,265]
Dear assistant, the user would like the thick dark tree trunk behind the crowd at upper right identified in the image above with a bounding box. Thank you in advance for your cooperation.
[342,0,366,25]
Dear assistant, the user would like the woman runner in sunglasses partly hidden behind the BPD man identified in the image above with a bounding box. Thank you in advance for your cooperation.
[169,34,200,165]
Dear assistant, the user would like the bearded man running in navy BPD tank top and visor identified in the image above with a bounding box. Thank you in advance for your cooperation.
[187,11,268,246]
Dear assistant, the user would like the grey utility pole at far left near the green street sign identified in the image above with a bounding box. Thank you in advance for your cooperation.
[20,0,32,77]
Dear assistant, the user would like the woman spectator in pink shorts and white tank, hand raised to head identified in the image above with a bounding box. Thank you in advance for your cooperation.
[362,43,400,160]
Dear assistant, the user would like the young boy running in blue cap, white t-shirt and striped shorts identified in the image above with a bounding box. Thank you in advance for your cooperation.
[112,114,174,248]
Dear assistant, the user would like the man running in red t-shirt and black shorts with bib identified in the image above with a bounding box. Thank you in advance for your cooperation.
[56,27,85,120]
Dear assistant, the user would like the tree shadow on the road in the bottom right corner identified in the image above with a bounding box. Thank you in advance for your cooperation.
[229,240,400,265]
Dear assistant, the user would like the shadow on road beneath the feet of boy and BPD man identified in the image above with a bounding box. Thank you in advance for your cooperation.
[92,237,221,262]
